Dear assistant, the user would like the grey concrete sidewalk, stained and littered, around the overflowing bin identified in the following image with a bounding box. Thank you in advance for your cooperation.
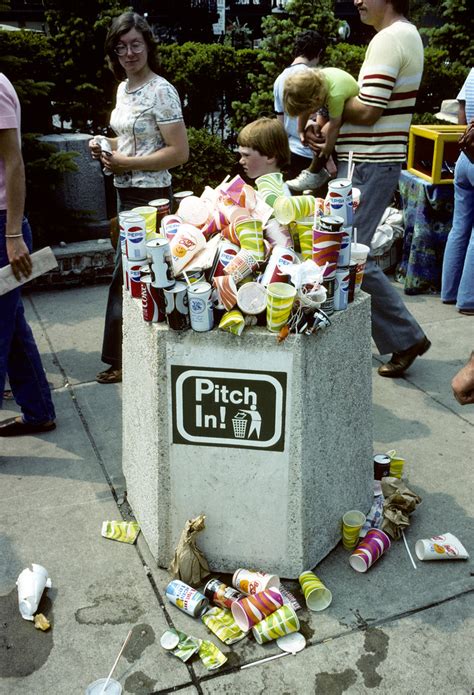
[0,285,474,695]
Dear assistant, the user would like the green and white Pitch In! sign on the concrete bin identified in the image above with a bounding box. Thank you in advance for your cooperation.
[171,365,286,451]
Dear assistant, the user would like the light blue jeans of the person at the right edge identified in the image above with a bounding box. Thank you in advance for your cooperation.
[441,152,474,310]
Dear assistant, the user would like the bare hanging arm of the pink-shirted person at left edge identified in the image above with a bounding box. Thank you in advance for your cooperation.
[0,128,32,280]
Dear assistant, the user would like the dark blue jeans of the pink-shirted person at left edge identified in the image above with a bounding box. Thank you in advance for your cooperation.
[0,215,56,424]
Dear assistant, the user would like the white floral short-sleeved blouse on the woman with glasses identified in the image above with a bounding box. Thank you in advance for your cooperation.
[110,75,183,188]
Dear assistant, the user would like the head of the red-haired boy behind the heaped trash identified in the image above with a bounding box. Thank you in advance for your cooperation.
[237,118,290,179]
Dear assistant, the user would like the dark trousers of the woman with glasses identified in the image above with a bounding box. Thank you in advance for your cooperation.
[102,186,172,369]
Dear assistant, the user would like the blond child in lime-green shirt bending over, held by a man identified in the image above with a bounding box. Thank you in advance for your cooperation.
[283,68,359,191]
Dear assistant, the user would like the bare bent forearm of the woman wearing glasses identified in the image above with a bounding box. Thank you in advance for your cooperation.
[101,121,189,174]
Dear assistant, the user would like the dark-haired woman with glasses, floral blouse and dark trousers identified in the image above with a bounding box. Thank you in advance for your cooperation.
[89,12,189,384]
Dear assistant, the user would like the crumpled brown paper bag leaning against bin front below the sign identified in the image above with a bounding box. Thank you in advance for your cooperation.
[168,514,210,586]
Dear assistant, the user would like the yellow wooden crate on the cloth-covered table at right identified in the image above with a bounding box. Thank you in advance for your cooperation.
[407,125,466,184]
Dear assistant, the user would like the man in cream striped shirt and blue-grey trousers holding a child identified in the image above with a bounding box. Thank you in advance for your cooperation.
[308,0,431,377]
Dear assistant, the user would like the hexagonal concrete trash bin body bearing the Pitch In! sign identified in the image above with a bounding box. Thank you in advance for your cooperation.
[123,293,373,578]
